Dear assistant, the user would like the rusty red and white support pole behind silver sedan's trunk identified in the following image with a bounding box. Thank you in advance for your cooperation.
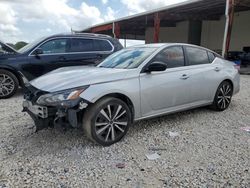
[222,0,234,58]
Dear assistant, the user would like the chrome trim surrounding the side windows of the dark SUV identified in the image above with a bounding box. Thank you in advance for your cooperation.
[28,37,115,57]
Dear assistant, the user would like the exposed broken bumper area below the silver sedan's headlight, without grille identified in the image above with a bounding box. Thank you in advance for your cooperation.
[23,99,88,131]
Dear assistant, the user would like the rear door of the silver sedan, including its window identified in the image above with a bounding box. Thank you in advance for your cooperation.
[185,46,221,104]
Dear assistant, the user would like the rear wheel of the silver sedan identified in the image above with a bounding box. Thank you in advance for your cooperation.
[217,82,233,109]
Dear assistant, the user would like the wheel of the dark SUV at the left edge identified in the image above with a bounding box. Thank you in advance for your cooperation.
[0,69,19,99]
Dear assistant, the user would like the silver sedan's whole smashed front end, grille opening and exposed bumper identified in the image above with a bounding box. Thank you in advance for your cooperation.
[23,84,89,131]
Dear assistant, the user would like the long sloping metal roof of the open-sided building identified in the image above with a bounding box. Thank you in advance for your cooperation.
[80,0,250,40]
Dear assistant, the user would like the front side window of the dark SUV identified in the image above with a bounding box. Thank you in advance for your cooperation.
[40,39,68,54]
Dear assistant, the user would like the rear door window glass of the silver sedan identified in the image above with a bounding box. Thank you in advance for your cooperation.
[186,47,210,65]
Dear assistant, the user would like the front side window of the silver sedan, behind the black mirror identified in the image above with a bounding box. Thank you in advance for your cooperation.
[153,46,185,68]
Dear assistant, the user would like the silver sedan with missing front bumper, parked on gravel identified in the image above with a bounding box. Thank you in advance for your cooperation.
[23,44,240,146]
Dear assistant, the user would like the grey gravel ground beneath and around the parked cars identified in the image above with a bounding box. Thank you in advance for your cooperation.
[0,76,250,188]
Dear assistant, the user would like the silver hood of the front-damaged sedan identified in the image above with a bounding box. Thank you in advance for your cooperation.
[30,66,132,92]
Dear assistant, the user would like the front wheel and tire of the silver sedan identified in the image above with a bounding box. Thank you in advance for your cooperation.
[83,97,132,146]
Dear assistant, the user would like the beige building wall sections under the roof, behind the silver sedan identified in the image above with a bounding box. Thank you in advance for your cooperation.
[146,11,250,51]
